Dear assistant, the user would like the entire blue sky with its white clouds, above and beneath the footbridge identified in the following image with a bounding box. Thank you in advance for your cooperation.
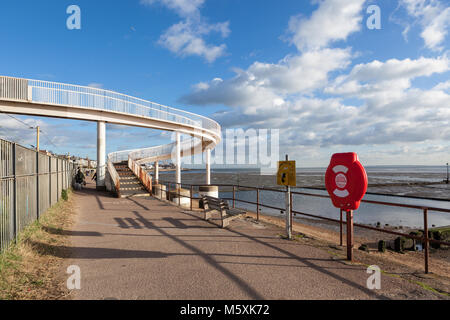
[0,0,450,166]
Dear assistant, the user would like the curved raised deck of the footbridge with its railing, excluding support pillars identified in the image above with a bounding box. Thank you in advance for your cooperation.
[0,76,221,162]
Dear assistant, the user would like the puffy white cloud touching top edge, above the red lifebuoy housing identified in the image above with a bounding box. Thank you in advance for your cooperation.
[289,0,365,50]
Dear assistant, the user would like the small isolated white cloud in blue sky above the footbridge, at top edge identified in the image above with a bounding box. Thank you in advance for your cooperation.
[141,0,230,63]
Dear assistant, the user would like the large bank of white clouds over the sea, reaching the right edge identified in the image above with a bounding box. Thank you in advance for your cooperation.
[182,0,450,165]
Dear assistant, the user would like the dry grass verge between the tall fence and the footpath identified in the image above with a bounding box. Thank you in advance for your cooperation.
[0,191,74,300]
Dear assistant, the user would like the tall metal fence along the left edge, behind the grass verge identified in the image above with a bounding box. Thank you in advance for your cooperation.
[0,139,75,251]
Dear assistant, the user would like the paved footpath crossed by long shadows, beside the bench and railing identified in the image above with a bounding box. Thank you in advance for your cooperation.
[64,182,444,300]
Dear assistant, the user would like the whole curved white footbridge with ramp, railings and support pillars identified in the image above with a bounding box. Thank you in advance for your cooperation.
[0,76,221,194]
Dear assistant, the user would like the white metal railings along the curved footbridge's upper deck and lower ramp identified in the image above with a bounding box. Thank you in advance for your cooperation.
[0,76,221,170]
